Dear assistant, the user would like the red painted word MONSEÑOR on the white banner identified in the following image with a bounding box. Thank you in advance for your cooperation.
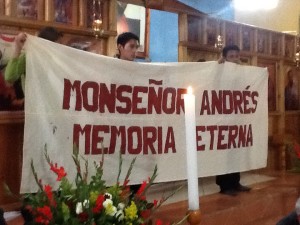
[62,79,186,115]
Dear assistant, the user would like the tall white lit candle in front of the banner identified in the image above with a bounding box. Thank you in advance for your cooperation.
[184,87,199,210]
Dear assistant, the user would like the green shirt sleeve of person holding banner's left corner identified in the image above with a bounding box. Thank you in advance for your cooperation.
[4,53,26,83]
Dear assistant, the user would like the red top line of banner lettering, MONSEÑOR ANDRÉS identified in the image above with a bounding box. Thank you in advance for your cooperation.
[63,79,259,115]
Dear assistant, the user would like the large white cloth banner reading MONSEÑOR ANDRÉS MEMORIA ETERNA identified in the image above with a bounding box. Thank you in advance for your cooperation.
[21,36,268,192]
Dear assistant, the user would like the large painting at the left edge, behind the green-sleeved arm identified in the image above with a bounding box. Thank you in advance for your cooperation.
[0,33,24,111]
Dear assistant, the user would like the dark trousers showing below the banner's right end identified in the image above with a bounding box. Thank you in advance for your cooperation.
[216,173,240,191]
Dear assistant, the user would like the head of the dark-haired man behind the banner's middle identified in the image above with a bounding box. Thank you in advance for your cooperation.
[117,32,140,61]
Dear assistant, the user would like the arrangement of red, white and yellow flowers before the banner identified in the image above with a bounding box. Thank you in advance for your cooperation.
[23,150,186,225]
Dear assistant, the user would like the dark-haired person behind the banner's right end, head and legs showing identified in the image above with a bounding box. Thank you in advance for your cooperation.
[216,45,251,196]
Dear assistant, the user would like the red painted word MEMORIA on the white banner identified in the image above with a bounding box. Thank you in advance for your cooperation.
[73,124,176,155]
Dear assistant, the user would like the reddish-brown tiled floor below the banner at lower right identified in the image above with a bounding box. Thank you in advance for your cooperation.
[4,172,300,225]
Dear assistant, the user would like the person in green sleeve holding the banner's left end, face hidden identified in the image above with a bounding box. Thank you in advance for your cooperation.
[5,27,62,97]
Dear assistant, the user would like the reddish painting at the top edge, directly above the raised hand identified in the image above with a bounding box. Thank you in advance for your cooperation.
[17,0,38,19]
